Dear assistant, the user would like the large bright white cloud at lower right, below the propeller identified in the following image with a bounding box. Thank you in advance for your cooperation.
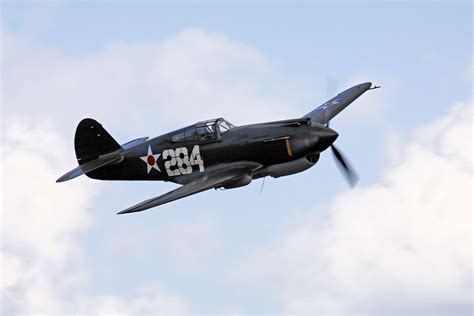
[232,103,472,314]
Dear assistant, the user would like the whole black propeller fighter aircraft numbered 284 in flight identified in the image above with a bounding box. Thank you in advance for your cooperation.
[57,82,379,214]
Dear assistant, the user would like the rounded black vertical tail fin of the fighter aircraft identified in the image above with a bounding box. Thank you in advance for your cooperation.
[74,118,121,165]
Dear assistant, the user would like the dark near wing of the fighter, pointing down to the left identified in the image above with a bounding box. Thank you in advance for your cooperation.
[117,162,261,214]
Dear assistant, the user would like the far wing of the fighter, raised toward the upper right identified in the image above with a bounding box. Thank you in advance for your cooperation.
[303,82,372,124]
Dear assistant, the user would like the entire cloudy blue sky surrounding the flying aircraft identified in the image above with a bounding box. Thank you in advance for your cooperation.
[0,1,473,315]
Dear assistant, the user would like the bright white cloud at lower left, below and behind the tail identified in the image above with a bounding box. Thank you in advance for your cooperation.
[1,120,191,315]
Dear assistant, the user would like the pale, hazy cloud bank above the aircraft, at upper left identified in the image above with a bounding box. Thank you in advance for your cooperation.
[2,29,310,137]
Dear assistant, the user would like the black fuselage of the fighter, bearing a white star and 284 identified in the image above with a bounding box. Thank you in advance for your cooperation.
[87,119,338,184]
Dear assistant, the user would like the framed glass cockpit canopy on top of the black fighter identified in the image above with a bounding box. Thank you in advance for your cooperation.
[171,118,234,142]
